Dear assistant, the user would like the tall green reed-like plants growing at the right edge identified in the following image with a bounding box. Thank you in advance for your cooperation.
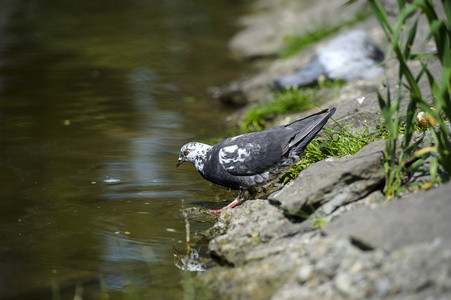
[368,0,451,198]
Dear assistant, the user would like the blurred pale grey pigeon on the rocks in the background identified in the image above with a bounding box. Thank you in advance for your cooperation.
[269,30,384,90]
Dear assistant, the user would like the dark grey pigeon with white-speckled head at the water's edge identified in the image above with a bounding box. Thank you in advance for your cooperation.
[176,108,335,213]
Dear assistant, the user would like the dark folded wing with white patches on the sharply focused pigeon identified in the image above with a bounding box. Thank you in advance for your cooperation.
[213,126,296,176]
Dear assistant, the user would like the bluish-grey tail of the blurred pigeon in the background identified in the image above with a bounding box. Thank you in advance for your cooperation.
[269,55,326,91]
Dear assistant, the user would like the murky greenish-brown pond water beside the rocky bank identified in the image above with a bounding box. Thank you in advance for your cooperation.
[0,0,247,299]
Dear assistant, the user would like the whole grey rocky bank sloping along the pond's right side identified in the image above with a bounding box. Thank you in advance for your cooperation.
[198,0,451,299]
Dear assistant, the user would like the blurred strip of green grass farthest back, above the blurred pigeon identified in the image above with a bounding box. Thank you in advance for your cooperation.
[279,12,368,58]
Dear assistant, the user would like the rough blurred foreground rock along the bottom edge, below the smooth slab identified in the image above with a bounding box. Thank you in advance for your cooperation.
[203,226,451,299]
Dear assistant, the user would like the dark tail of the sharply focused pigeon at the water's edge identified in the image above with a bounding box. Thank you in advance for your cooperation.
[287,107,336,153]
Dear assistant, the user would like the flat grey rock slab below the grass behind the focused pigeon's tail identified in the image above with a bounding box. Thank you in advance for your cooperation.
[268,140,385,216]
